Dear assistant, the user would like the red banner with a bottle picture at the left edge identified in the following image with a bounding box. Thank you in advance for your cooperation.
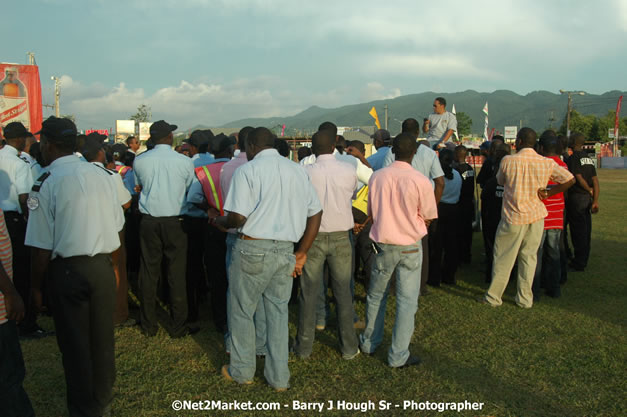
[0,63,42,133]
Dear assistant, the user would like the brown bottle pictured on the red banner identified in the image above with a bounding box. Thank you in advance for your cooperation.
[0,67,30,129]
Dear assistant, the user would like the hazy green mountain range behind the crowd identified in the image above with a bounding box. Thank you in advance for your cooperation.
[217,90,626,135]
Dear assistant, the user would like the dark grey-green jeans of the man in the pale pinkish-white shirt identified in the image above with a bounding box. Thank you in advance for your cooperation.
[294,231,358,357]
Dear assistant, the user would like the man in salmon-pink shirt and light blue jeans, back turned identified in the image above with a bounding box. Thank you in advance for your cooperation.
[360,133,438,368]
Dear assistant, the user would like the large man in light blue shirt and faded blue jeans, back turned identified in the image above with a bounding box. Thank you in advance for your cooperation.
[213,127,322,391]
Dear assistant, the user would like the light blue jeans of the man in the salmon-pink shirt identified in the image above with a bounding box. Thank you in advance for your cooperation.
[360,242,422,367]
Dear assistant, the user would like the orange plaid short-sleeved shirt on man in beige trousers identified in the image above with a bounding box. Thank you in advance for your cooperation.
[496,148,573,224]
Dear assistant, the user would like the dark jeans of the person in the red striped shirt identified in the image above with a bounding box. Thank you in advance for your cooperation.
[533,229,562,297]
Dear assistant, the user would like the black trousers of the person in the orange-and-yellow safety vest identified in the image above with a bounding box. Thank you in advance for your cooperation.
[205,226,229,332]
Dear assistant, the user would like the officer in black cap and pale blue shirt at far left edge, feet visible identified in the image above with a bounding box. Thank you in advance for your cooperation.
[0,122,49,338]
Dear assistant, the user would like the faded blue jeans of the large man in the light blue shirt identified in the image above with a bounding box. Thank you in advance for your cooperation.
[228,239,296,388]
